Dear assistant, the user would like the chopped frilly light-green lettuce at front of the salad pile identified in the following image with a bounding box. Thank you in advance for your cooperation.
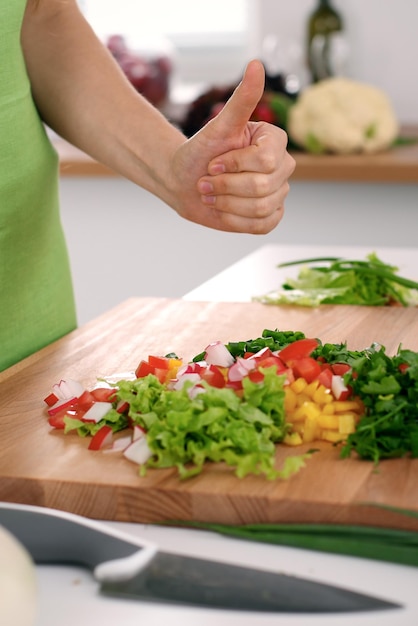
[113,368,309,479]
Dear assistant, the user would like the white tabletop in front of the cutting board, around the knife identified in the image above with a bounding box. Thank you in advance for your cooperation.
[36,523,418,626]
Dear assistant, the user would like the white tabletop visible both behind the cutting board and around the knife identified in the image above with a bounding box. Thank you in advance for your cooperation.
[26,245,418,626]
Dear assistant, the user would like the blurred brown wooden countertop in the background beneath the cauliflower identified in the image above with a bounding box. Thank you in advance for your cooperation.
[53,128,418,183]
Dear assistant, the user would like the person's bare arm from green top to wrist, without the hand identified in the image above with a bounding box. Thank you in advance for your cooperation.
[22,0,185,205]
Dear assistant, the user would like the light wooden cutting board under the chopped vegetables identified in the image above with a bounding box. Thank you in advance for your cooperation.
[0,298,418,530]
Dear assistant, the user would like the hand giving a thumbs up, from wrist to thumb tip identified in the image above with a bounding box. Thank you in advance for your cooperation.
[173,61,295,234]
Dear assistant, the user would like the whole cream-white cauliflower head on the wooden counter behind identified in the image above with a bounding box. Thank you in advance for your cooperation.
[287,77,399,154]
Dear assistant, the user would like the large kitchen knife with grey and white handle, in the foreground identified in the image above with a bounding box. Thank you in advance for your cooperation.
[0,502,401,613]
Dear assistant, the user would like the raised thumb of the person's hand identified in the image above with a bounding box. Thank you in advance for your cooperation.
[213,60,265,134]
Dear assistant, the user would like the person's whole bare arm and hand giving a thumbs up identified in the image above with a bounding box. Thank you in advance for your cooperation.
[22,0,295,234]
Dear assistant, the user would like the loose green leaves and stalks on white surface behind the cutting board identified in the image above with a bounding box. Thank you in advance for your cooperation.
[253,253,418,306]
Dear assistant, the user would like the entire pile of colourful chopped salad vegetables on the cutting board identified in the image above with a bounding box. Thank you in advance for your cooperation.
[45,329,418,480]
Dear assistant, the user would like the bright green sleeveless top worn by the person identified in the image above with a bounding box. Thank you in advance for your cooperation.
[0,0,76,371]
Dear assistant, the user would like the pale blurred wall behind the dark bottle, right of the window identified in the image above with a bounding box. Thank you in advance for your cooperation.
[250,0,418,124]
